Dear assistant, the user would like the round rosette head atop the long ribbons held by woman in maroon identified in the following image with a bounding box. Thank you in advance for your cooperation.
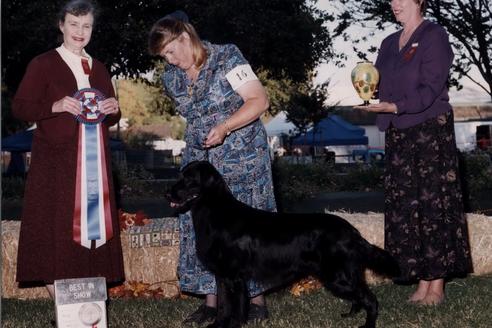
[73,88,106,124]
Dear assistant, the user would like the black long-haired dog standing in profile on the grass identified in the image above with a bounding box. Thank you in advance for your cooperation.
[166,161,399,328]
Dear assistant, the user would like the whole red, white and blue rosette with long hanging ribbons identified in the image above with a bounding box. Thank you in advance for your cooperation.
[73,88,113,249]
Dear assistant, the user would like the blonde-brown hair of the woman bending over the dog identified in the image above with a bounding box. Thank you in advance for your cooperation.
[149,17,207,67]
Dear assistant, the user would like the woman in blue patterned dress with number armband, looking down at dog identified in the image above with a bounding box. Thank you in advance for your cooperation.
[149,11,276,323]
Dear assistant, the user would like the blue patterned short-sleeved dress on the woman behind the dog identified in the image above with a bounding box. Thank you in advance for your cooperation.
[162,42,276,296]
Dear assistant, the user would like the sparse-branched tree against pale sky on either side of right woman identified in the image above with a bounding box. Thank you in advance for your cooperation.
[336,0,492,100]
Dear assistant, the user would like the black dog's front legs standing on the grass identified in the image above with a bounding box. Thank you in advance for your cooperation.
[209,277,248,328]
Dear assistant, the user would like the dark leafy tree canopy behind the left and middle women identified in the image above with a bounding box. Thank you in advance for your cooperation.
[1,0,333,133]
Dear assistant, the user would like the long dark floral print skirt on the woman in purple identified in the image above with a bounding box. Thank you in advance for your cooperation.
[384,111,472,282]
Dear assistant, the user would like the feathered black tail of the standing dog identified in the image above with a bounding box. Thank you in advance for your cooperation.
[363,240,400,278]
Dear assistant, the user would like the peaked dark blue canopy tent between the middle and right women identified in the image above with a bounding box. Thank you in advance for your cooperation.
[293,115,369,147]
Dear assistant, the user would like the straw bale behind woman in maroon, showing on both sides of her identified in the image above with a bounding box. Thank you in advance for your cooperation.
[2,218,179,299]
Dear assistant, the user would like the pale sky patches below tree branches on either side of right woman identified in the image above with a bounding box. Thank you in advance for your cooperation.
[315,0,490,106]
